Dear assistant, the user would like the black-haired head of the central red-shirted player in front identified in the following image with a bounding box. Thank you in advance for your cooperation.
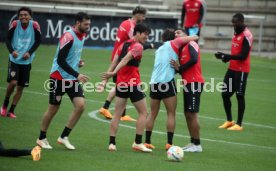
[133,23,151,44]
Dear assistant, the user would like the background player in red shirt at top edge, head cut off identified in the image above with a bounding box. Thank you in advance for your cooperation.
[180,0,206,36]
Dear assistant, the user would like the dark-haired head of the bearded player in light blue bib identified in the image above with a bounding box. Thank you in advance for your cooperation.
[75,12,91,33]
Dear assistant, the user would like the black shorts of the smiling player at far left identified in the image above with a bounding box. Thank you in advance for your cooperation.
[7,61,32,87]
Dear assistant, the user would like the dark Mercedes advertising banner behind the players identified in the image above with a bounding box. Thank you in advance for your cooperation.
[0,10,177,47]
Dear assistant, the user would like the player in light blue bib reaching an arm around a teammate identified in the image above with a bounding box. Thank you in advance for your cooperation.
[144,29,198,150]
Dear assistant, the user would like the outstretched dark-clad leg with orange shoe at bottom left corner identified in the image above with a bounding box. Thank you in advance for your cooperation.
[0,141,41,161]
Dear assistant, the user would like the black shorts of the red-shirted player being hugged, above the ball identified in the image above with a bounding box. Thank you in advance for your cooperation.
[183,82,204,113]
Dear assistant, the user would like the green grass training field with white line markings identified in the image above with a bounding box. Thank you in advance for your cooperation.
[0,43,276,171]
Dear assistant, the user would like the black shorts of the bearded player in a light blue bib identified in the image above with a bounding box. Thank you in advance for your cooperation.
[49,78,84,105]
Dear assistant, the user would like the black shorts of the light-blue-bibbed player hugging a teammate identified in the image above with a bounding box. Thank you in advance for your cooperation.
[150,79,177,100]
